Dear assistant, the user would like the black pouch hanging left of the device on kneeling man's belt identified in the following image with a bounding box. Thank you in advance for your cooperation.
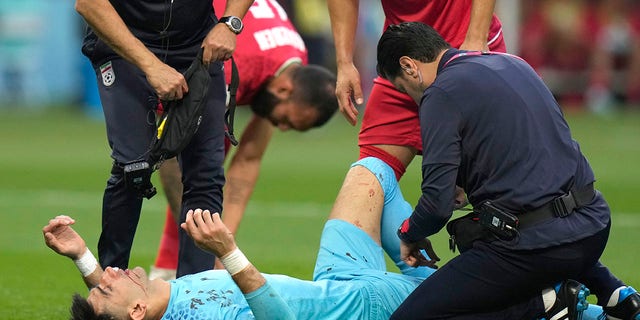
[447,212,494,253]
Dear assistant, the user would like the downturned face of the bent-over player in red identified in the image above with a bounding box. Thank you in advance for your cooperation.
[269,100,318,131]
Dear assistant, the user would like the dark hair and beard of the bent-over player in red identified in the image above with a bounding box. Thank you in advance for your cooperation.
[251,65,338,127]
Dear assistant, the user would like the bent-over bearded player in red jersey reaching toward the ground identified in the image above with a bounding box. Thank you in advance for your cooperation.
[149,0,338,280]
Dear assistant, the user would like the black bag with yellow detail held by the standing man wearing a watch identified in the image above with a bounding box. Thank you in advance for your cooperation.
[147,51,211,166]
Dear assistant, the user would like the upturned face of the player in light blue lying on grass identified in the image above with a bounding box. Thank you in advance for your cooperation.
[87,267,149,318]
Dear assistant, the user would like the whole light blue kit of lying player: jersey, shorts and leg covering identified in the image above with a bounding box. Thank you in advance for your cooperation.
[162,158,433,320]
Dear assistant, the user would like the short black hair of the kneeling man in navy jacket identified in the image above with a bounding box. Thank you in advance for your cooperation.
[376,22,451,79]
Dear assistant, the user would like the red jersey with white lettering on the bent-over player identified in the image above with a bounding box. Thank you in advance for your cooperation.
[213,0,307,105]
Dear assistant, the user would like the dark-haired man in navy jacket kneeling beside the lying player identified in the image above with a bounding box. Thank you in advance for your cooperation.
[378,22,640,319]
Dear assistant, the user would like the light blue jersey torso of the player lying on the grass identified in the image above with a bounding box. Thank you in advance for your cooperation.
[162,270,420,320]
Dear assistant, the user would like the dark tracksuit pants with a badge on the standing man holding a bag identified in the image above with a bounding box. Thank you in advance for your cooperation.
[94,53,226,276]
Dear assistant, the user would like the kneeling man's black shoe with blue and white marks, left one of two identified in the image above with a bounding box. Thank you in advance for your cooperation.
[545,280,589,320]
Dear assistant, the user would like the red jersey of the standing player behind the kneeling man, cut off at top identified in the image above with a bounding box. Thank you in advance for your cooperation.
[380,0,502,48]
